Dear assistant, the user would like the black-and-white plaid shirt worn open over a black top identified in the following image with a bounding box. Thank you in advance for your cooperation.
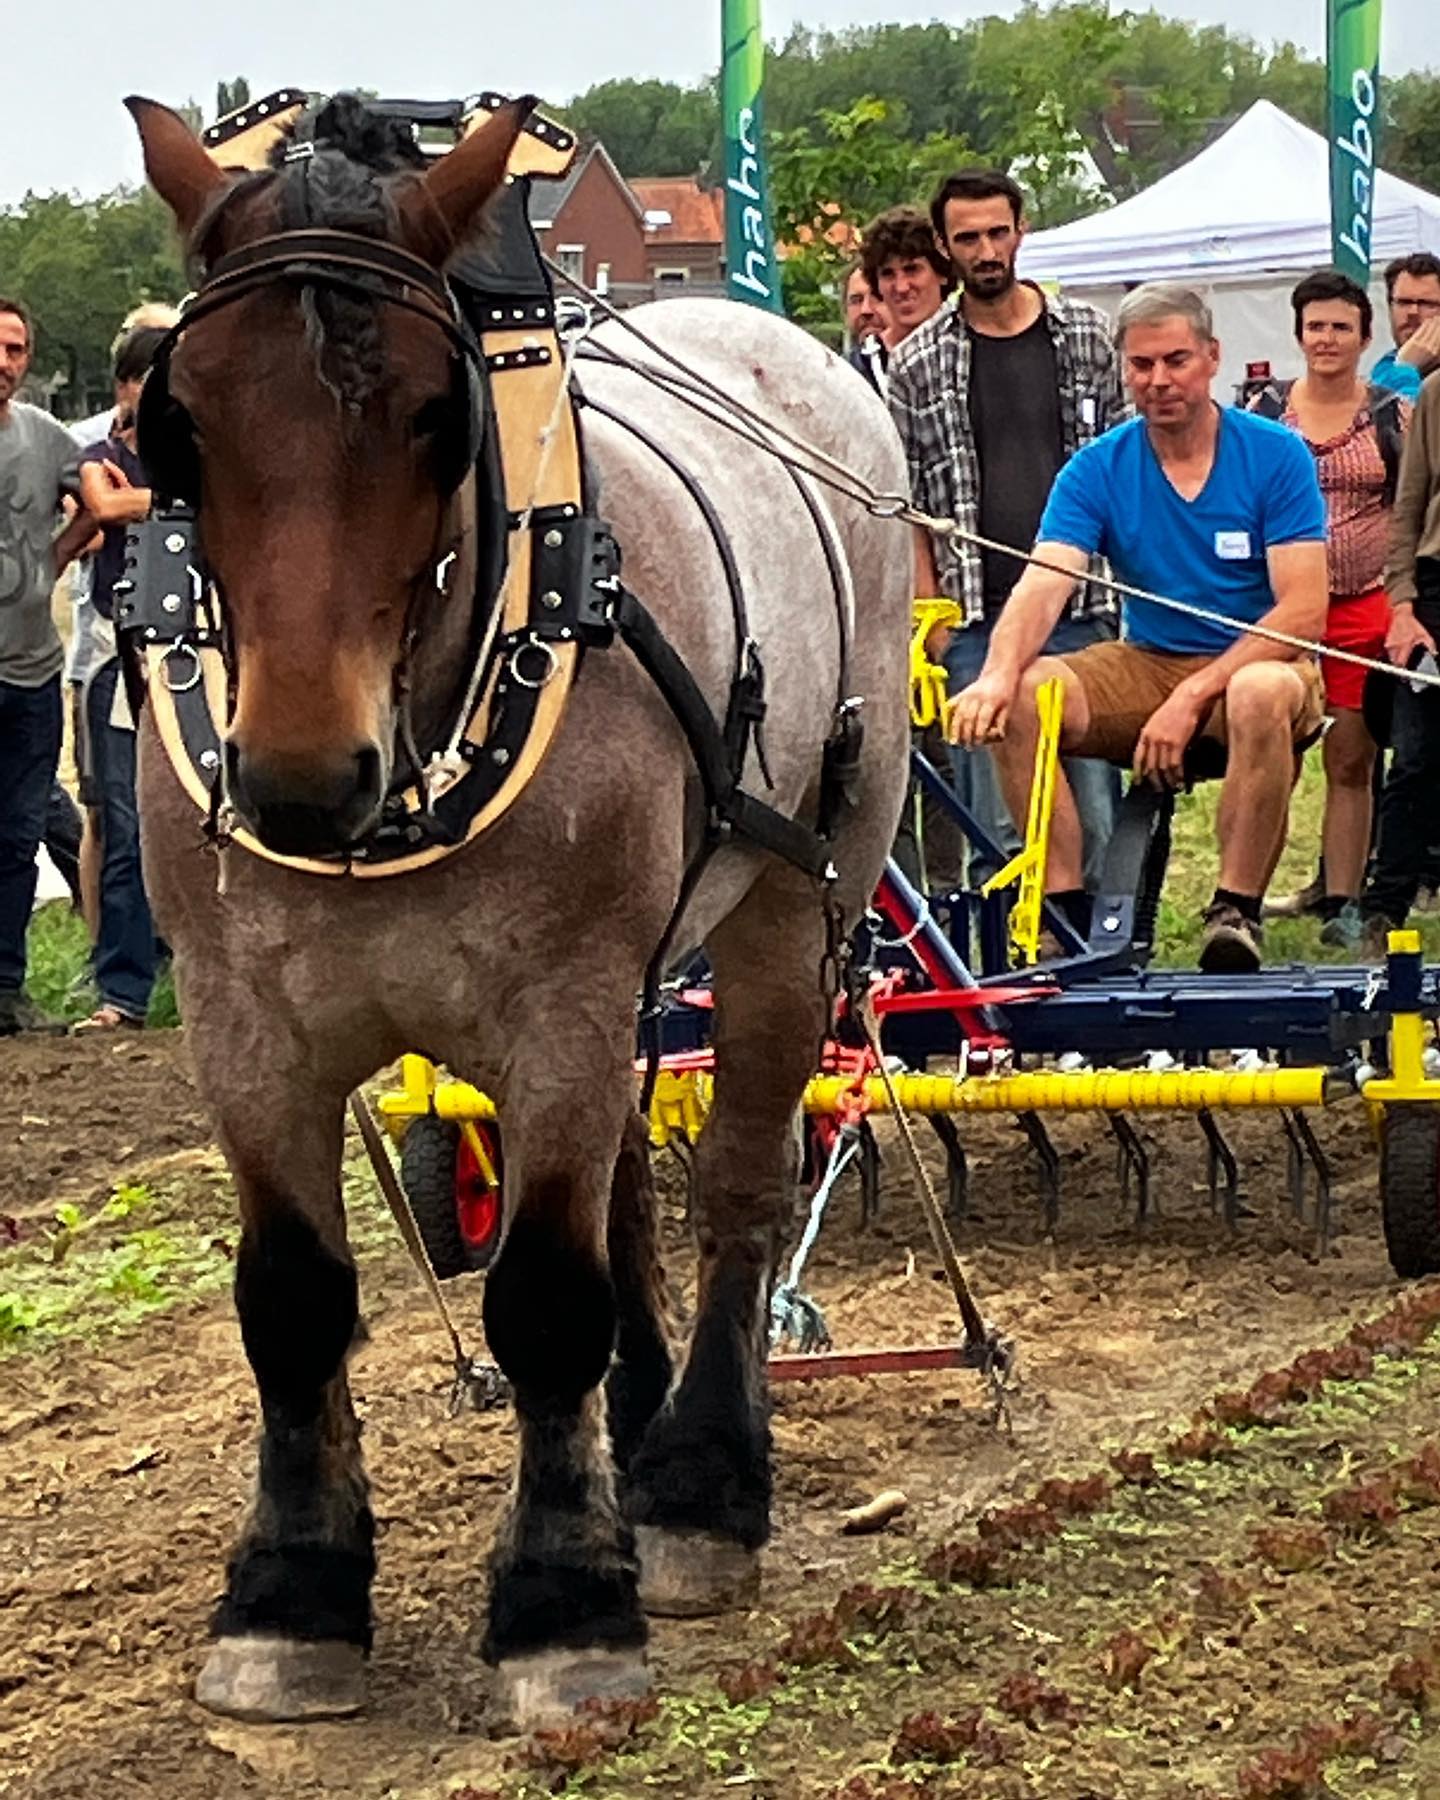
[889,280,1125,625]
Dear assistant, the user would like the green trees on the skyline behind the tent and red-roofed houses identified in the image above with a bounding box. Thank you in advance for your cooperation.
[569,0,1440,206]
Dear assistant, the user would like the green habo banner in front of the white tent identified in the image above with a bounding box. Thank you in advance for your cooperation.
[1327,0,1381,288]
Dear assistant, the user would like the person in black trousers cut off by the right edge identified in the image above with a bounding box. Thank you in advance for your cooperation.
[1361,371,1440,952]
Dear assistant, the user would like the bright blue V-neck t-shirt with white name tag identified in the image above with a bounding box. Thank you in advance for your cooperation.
[1039,407,1325,655]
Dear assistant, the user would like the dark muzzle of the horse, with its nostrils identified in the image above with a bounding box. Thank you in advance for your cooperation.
[225,740,385,857]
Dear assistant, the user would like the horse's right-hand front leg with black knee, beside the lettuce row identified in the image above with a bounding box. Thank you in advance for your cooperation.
[484,1044,648,1728]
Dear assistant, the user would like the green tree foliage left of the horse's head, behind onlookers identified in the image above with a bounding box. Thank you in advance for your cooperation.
[0,187,187,418]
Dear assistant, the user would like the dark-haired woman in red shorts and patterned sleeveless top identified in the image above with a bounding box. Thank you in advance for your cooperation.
[1253,268,1409,950]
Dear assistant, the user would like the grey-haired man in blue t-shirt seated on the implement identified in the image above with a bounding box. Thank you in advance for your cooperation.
[949,283,1328,972]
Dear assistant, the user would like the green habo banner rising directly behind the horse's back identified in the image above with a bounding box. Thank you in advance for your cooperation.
[720,0,781,313]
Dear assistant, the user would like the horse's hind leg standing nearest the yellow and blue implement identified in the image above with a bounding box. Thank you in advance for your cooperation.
[626,900,826,1616]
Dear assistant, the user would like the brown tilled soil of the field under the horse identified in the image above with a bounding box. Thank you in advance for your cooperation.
[0,1035,1440,1800]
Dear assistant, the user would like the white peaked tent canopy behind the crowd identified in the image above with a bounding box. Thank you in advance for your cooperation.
[1021,101,1440,288]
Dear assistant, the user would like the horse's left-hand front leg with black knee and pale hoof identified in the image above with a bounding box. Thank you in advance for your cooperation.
[196,1058,374,1721]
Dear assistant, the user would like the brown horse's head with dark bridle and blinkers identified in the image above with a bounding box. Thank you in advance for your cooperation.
[126,99,531,855]
